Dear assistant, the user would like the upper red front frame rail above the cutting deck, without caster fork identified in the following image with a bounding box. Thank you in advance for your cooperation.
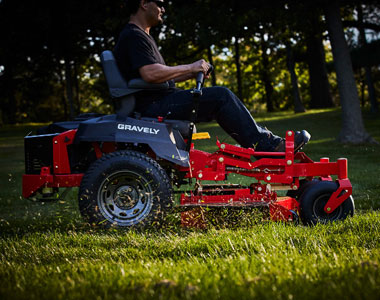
[182,131,347,184]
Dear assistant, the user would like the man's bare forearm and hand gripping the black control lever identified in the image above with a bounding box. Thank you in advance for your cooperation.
[139,59,209,83]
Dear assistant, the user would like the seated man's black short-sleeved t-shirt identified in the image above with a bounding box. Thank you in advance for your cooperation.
[113,24,175,112]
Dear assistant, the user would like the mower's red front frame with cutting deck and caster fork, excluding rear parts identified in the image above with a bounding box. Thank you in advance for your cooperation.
[180,131,352,221]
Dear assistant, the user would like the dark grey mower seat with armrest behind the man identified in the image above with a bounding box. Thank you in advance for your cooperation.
[100,50,196,138]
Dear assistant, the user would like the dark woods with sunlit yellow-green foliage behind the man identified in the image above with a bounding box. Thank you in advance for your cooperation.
[0,0,380,142]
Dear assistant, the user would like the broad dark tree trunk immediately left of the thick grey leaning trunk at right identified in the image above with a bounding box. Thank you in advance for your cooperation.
[306,14,334,108]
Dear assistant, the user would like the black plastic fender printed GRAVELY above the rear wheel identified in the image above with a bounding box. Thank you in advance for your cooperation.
[75,115,189,167]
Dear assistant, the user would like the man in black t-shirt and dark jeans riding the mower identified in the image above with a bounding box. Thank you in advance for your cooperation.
[114,0,310,152]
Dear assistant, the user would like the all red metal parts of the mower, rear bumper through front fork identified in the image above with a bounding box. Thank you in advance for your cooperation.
[23,130,352,225]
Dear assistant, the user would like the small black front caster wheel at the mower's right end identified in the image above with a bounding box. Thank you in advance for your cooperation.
[300,181,355,225]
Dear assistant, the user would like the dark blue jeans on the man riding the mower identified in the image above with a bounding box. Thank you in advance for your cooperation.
[141,87,281,151]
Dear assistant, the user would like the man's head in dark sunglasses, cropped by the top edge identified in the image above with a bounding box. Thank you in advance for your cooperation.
[126,0,165,26]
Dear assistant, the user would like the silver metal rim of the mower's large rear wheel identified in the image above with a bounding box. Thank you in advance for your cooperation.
[97,171,153,226]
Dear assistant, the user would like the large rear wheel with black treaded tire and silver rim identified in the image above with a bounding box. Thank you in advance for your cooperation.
[79,151,172,228]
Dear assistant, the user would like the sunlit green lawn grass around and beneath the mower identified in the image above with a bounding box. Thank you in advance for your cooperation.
[0,110,380,299]
